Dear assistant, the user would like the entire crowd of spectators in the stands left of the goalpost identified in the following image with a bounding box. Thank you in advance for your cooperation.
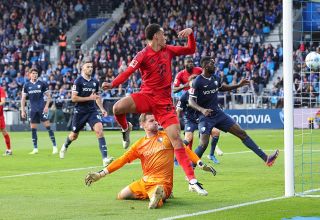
[0,0,282,113]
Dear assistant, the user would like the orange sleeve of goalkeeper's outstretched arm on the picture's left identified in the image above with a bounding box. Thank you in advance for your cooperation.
[107,139,141,173]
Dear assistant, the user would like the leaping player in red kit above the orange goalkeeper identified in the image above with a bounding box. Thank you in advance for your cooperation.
[102,24,208,195]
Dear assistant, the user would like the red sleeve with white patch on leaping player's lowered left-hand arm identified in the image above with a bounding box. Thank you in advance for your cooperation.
[111,51,144,88]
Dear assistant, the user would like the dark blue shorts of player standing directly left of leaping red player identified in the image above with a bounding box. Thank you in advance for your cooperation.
[72,111,102,133]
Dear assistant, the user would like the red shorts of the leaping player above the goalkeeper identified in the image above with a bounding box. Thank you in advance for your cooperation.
[131,92,180,128]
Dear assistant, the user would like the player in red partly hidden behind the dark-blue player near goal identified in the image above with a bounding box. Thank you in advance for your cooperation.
[173,56,202,93]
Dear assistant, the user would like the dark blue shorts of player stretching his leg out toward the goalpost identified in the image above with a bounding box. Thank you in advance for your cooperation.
[199,111,236,135]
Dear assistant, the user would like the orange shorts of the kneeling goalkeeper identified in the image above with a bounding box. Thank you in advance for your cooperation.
[129,179,172,200]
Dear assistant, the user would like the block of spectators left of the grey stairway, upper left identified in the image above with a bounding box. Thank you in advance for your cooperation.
[0,0,88,108]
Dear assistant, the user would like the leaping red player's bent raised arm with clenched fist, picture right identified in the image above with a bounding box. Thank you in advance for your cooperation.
[167,28,196,56]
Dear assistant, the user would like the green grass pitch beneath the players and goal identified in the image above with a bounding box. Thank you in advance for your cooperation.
[0,130,320,220]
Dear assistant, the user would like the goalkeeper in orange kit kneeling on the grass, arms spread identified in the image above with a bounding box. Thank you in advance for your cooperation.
[85,113,216,209]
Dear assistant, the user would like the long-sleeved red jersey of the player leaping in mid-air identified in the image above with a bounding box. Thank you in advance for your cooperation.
[112,33,196,98]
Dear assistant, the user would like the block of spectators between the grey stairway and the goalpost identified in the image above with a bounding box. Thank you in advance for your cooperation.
[93,0,282,102]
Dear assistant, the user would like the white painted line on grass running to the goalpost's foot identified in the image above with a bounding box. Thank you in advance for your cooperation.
[160,196,287,220]
